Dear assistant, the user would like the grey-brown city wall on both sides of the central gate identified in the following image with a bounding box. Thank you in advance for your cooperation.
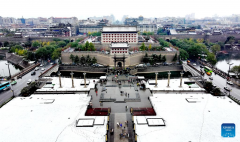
[61,51,179,67]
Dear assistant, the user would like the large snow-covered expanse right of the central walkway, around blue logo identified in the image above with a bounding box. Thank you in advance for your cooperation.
[134,93,240,142]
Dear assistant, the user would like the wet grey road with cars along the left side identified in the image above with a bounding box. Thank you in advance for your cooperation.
[0,64,52,105]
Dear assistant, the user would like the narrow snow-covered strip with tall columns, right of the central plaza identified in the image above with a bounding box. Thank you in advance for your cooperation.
[146,78,205,91]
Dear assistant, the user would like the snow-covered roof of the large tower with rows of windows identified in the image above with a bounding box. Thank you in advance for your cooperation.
[102,27,137,32]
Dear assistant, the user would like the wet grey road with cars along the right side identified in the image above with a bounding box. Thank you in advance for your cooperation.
[192,60,240,100]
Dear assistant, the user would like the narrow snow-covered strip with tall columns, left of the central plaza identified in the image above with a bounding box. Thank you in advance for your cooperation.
[37,77,99,91]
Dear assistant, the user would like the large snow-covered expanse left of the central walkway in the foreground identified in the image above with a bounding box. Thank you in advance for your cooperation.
[0,94,107,142]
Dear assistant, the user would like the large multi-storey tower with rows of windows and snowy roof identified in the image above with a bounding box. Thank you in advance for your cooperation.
[101,26,138,44]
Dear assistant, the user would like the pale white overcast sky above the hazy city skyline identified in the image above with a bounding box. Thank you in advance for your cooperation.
[0,0,240,20]
